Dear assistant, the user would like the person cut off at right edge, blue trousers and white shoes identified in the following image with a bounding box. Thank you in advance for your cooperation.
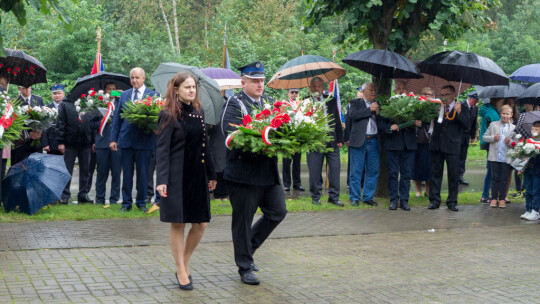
[518,120,540,221]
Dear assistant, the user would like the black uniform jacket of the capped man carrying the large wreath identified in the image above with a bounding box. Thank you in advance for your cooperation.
[221,91,281,186]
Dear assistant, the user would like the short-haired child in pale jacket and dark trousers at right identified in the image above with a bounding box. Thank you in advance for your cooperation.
[483,105,516,208]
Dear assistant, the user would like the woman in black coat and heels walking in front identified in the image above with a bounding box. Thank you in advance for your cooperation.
[156,72,216,290]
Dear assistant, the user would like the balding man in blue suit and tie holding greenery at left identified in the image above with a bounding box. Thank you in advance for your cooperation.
[109,68,158,212]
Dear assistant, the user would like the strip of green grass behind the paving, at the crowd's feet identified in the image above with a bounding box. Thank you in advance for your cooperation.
[0,192,523,223]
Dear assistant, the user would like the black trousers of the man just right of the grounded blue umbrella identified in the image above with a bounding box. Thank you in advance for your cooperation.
[62,146,92,199]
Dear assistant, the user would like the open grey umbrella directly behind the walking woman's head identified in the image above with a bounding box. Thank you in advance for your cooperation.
[150,62,223,125]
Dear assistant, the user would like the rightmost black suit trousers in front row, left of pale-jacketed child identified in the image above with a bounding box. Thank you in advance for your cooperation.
[429,151,459,206]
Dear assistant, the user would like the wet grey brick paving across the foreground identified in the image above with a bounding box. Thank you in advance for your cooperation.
[0,204,540,303]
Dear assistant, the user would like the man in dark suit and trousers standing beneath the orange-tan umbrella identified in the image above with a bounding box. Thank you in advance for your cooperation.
[307,77,343,207]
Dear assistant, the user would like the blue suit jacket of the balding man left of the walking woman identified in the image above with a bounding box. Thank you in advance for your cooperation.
[109,88,159,151]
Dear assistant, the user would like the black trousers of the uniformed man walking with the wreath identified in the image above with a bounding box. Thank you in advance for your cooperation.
[228,182,287,275]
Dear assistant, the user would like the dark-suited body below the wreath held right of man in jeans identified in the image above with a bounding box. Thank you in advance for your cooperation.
[377,106,422,211]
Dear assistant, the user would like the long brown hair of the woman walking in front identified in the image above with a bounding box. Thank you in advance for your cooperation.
[163,72,201,125]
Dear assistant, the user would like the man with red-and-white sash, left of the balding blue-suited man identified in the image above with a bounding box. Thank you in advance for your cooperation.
[94,83,122,204]
